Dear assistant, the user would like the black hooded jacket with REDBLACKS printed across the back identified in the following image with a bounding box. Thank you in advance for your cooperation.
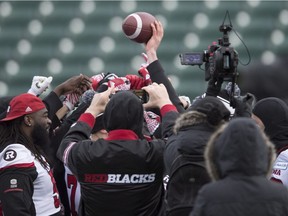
[58,91,177,216]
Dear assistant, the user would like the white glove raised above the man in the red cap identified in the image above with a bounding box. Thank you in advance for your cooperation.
[28,76,53,96]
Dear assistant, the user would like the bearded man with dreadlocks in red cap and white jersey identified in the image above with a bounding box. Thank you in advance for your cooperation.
[0,93,61,216]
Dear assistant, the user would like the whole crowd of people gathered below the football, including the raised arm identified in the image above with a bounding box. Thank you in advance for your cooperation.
[0,21,288,216]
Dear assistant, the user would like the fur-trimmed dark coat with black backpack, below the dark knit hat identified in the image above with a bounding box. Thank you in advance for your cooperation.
[164,112,215,216]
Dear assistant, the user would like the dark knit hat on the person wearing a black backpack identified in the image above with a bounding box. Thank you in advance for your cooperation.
[187,96,230,125]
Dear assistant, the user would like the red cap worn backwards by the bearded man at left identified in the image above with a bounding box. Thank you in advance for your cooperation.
[0,93,46,121]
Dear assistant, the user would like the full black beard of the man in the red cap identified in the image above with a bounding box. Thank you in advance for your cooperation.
[31,124,50,152]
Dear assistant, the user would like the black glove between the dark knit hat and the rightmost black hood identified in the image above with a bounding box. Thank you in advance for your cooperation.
[230,93,256,118]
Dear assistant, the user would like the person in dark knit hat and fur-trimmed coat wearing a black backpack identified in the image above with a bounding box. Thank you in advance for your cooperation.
[164,96,230,216]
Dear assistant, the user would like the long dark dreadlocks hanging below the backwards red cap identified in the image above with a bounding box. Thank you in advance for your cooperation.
[0,117,49,171]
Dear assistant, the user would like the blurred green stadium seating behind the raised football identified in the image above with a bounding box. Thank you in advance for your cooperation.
[0,1,288,98]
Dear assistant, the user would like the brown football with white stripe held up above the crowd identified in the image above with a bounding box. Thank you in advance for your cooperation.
[122,12,156,43]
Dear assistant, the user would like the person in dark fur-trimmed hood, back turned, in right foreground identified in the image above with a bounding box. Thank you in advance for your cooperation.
[190,118,288,216]
